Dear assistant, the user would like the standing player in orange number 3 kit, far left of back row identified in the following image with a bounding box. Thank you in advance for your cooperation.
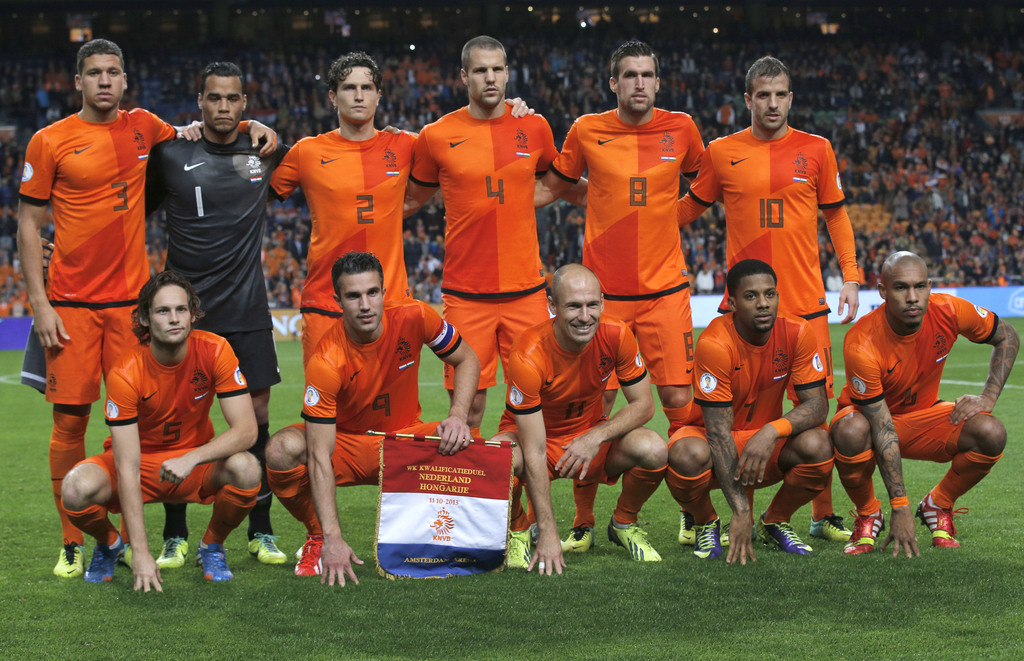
[17,39,276,578]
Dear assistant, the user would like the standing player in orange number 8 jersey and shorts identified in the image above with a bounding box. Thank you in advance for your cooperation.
[536,41,703,552]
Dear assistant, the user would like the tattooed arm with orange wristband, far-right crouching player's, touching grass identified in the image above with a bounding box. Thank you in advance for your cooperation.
[860,399,921,558]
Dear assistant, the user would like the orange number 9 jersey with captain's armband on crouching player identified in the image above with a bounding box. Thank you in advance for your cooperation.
[302,301,462,434]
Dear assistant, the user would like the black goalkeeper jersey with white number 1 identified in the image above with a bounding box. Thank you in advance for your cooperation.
[145,133,288,334]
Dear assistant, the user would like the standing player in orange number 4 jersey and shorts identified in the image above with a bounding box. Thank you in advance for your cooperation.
[406,37,569,433]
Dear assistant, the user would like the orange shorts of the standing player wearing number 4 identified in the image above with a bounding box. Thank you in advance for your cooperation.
[442,290,551,390]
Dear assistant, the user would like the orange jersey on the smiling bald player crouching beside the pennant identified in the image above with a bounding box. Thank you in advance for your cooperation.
[501,317,647,438]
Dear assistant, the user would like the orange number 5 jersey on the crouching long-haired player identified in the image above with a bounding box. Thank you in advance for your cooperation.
[106,329,249,452]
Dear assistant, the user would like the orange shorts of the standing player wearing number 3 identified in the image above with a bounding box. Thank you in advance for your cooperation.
[46,305,138,404]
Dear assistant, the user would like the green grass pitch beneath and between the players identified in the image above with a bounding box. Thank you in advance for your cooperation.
[0,319,1024,659]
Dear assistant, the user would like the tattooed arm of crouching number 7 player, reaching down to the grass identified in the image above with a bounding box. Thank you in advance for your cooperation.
[700,406,757,565]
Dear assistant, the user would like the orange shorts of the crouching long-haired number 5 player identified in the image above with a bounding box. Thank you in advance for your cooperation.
[81,448,220,512]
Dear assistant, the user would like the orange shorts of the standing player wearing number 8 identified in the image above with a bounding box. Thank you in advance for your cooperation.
[604,288,693,390]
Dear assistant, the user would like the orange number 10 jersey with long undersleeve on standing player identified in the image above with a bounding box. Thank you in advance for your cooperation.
[690,129,856,317]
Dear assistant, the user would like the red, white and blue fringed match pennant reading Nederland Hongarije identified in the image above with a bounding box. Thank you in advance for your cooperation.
[376,434,512,579]
